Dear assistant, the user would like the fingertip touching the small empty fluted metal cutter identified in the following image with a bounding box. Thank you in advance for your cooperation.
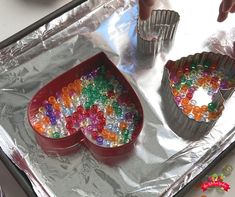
[139,0,155,20]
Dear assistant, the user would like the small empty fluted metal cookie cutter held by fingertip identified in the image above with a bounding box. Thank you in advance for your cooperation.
[137,10,180,55]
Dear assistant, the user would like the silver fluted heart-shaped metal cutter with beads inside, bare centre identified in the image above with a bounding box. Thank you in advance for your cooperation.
[160,52,235,140]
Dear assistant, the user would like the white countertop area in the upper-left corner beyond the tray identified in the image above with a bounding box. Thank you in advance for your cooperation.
[0,0,72,42]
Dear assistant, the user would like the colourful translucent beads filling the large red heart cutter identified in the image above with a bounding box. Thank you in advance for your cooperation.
[32,66,141,147]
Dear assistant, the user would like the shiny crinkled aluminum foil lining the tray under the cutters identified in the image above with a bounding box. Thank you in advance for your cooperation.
[0,0,235,197]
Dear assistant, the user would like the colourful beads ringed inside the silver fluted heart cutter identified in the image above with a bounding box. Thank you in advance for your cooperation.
[168,62,234,122]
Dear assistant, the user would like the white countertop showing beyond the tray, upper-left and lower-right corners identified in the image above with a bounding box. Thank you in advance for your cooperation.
[0,0,235,197]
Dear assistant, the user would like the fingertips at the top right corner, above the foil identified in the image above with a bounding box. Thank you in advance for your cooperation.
[217,0,235,22]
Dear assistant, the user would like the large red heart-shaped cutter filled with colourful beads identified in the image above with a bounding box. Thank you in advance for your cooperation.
[28,53,143,160]
